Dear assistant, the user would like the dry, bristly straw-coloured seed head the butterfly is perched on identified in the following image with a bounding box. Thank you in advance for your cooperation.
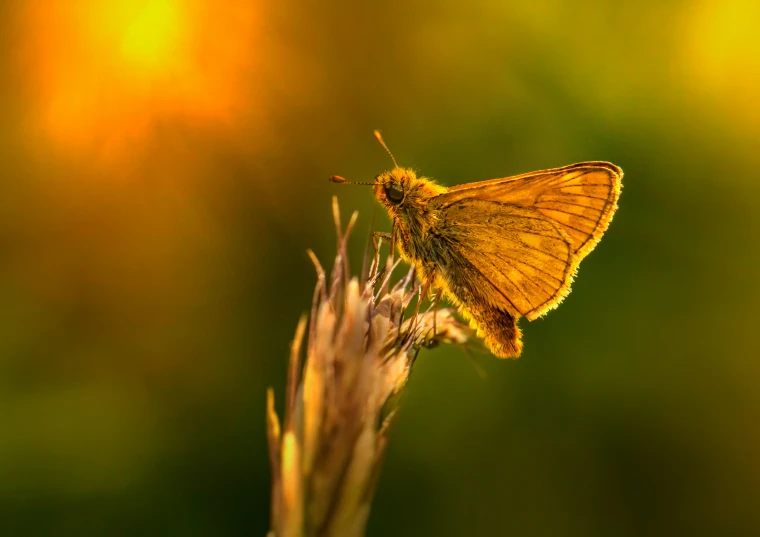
[267,198,468,537]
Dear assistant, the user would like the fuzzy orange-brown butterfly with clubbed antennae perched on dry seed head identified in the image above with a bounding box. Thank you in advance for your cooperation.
[331,131,623,358]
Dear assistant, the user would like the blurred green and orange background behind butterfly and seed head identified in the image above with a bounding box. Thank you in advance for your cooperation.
[0,0,760,536]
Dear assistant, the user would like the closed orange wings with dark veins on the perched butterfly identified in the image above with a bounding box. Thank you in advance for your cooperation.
[431,162,623,320]
